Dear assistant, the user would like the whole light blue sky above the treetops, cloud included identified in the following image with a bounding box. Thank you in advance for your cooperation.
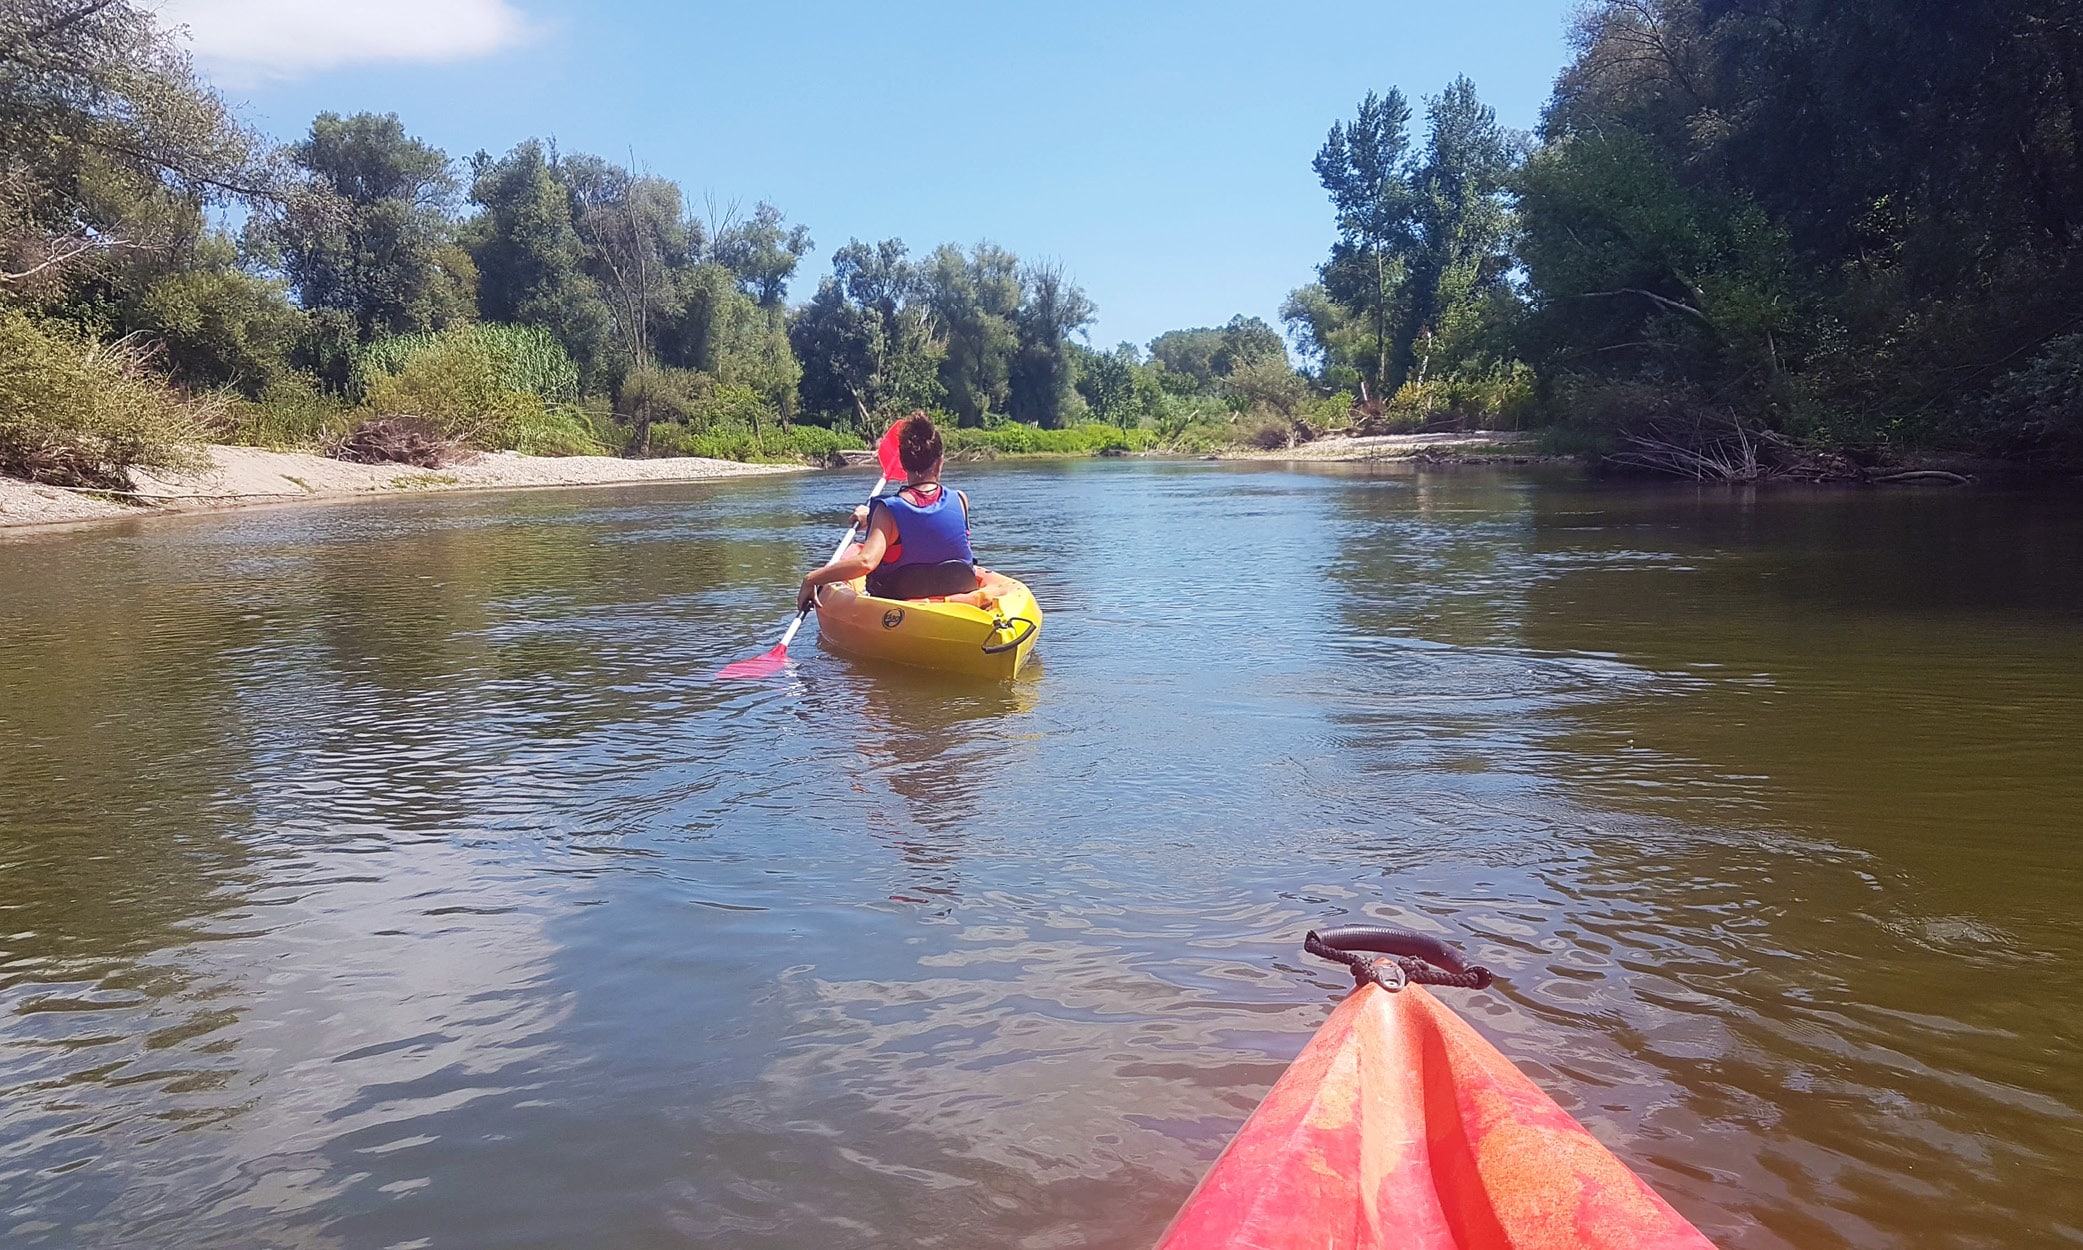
[160,0,1571,346]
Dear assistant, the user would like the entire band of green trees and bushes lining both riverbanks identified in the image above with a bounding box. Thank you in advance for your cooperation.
[0,0,2083,475]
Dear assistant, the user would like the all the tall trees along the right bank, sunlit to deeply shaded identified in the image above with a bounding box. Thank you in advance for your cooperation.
[1283,0,2083,477]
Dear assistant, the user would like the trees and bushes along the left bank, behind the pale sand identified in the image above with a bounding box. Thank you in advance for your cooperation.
[0,0,1208,479]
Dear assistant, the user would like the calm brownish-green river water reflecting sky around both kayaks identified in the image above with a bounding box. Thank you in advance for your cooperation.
[0,460,2083,1250]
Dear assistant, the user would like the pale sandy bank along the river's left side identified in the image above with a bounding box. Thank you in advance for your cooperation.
[0,446,798,527]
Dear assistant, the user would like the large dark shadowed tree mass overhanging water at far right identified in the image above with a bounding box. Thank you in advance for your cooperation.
[1521,0,2083,458]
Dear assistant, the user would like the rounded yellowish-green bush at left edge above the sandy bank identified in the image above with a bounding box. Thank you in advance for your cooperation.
[0,308,204,490]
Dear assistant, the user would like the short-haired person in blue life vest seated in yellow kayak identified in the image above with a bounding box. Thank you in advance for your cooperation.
[796,413,989,610]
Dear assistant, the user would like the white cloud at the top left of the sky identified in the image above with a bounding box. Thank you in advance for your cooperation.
[158,0,531,85]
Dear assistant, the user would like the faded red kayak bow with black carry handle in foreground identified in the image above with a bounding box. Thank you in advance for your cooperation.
[1158,927,1712,1250]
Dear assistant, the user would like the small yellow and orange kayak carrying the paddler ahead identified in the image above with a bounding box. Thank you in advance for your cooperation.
[817,573,1042,677]
